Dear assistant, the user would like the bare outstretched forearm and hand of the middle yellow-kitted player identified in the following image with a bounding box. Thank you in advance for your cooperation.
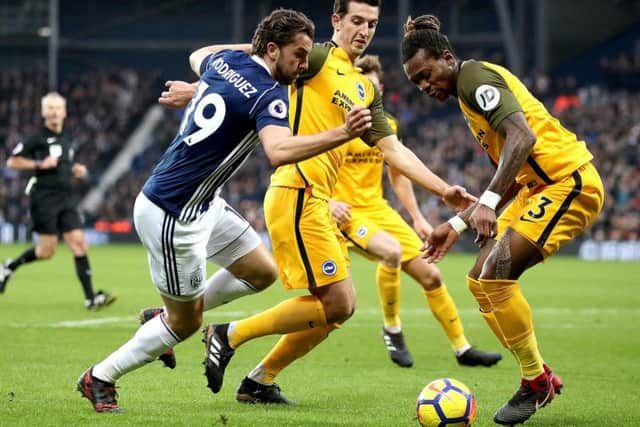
[376,135,476,211]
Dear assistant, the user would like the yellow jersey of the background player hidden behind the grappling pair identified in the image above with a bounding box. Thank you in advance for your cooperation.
[332,114,400,207]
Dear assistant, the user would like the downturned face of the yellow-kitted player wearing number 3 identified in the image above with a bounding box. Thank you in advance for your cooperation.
[404,49,455,102]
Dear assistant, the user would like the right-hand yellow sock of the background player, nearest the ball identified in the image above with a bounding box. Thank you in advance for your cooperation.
[424,283,469,351]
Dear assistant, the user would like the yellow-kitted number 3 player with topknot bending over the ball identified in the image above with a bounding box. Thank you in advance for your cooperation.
[402,15,604,425]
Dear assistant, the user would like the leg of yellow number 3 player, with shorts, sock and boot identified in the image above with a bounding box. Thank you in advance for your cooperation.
[490,164,603,424]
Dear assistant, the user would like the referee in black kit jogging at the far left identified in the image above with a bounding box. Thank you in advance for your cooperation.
[0,92,115,310]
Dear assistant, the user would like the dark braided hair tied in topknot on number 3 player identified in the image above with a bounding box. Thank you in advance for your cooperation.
[401,15,453,64]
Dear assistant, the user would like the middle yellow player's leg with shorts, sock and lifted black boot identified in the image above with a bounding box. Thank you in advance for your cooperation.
[206,187,355,392]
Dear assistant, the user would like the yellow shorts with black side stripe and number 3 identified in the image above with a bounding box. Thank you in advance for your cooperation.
[497,163,604,258]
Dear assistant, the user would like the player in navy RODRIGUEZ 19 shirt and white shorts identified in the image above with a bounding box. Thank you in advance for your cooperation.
[78,9,371,412]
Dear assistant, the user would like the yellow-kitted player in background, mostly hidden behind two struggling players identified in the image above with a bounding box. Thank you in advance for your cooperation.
[329,55,502,367]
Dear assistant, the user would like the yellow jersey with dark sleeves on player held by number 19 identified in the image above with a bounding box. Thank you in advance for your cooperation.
[271,43,393,199]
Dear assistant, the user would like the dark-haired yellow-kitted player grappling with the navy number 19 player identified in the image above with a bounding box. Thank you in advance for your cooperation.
[198,0,475,404]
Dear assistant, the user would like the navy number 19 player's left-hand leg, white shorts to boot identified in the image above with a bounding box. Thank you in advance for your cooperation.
[78,193,208,412]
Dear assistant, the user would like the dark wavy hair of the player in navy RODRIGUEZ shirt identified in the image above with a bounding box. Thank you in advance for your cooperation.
[251,9,316,56]
